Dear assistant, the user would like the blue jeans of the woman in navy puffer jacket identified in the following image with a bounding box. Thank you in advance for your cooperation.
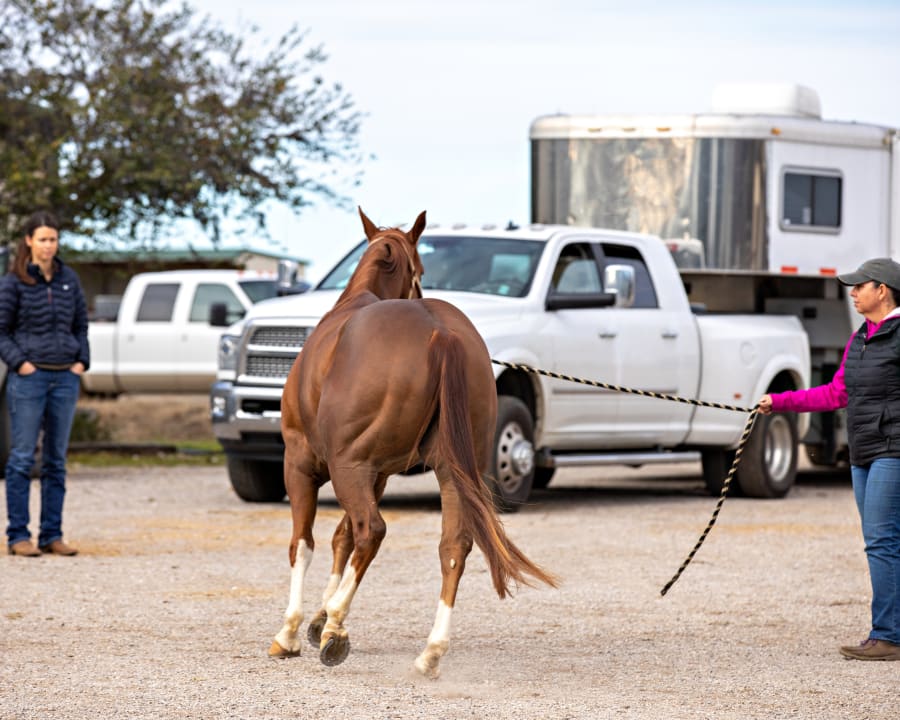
[6,369,81,547]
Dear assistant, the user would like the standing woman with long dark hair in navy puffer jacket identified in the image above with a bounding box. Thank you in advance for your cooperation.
[0,211,90,557]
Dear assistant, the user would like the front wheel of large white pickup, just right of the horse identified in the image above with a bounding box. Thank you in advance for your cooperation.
[488,395,534,512]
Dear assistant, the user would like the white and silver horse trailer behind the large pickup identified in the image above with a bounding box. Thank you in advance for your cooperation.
[530,85,900,465]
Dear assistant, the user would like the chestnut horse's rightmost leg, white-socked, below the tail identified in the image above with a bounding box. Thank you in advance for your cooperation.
[415,472,472,679]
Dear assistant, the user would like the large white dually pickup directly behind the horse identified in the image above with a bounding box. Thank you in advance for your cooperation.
[210,226,810,507]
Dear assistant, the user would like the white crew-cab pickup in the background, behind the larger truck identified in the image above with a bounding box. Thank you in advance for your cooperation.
[82,270,277,395]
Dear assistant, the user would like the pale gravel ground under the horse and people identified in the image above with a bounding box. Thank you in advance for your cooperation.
[0,467,900,720]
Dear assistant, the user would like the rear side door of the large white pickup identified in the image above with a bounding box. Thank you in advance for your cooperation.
[595,243,700,447]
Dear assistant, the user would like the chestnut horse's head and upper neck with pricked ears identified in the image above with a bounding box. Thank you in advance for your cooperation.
[348,208,425,300]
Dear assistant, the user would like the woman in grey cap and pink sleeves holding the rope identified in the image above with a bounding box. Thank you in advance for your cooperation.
[759,258,900,660]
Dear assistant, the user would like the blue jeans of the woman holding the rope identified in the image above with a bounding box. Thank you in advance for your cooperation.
[851,458,900,645]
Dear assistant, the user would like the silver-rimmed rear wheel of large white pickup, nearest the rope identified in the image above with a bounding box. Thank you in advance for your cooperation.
[737,413,798,498]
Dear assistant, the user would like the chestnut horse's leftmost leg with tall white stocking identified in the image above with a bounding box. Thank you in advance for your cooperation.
[269,464,318,658]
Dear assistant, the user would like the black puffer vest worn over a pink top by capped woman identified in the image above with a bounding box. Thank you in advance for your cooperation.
[844,317,900,465]
